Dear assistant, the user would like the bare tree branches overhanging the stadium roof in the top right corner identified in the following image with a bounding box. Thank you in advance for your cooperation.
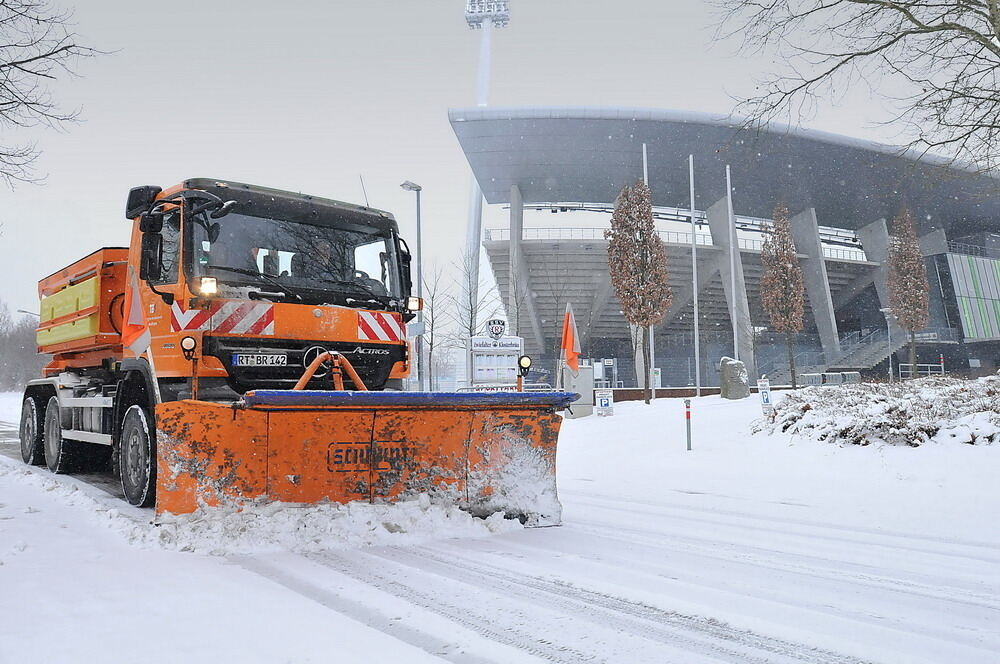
[715,0,1000,171]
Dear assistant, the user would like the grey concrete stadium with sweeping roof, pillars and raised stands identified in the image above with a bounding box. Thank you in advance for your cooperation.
[449,107,1000,385]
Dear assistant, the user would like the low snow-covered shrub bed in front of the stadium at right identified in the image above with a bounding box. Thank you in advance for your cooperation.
[754,376,1000,447]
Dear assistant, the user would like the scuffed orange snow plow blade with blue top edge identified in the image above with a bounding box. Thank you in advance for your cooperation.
[156,390,579,526]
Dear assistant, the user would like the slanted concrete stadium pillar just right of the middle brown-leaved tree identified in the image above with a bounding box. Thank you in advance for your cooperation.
[789,208,840,362]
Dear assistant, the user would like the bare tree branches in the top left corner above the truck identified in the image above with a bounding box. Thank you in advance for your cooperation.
[0,0,98,185]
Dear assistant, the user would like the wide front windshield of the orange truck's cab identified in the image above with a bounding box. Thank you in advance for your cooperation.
[189,213,401,304]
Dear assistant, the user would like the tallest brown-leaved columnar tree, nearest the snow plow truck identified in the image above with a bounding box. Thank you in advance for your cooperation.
[604,182,672,403]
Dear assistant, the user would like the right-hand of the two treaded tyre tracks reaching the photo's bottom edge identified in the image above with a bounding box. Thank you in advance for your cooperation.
[346,547,876,664]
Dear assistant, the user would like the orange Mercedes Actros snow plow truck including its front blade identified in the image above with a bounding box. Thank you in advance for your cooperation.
[20,179,577,525]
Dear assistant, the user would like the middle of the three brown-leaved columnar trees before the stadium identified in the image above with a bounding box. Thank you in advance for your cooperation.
[760,205,805,388]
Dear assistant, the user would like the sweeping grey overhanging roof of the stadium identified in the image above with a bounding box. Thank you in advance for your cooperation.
[448,107,1000,237]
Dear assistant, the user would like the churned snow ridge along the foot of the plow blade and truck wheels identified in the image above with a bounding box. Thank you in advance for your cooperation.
[0,457,522,555]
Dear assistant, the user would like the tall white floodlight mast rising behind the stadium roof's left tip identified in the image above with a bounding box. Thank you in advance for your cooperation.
[462,0,510,385]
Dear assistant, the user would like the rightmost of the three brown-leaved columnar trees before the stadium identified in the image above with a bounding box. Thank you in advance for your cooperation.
[889,208,930,376]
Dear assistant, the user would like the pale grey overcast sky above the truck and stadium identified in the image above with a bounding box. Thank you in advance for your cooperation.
[0,0,904,311]
